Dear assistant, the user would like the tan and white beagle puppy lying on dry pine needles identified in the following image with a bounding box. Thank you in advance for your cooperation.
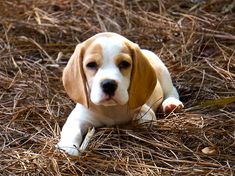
[57,32,183,156]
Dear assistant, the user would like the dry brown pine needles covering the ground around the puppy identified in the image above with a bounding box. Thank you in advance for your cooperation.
[0,0,235,176]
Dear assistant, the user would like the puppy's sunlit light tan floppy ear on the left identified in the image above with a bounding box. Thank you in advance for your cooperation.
[62,44,88,107]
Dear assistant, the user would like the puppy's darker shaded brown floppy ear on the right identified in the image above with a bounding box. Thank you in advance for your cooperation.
[128,43,157,109]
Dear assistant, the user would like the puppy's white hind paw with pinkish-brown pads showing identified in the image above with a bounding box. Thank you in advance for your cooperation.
[162,97,184,113]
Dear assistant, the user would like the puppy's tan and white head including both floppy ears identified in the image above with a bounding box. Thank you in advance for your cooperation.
[63,32,157,109]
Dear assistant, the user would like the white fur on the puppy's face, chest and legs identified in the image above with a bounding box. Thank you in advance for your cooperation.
[57,33,183,156]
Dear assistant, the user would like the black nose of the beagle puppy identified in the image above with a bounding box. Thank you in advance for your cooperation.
[101,79,117,96]
